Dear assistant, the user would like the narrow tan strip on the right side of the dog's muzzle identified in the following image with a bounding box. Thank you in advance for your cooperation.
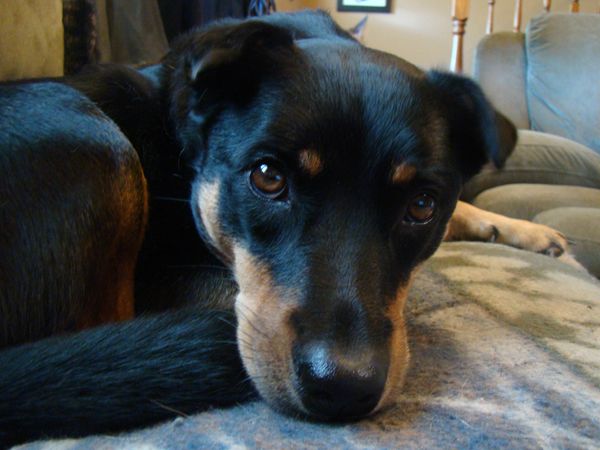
[373,268,418,412]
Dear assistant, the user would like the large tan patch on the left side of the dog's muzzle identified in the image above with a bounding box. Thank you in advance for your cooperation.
[233,245,303,409]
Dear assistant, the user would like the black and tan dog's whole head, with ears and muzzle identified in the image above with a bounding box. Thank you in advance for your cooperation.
[166,14,515,419]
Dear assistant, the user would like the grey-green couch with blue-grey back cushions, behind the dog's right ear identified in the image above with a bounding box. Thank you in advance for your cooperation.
[463,14,600,277]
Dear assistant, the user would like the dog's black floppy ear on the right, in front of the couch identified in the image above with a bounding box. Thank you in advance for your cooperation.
[427,71,517,180]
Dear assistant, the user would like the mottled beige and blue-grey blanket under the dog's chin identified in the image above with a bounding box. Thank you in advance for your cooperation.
[16,243,600,450]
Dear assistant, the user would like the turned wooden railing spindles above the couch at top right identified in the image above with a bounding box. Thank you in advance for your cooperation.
[450,0,600,73]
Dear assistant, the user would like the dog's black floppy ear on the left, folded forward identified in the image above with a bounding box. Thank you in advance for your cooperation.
[161,19,297,164]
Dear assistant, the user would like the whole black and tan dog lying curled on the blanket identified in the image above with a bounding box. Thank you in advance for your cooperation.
[0,9,565,445]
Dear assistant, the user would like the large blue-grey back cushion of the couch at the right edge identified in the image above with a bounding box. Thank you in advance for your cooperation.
[525,14,600,153]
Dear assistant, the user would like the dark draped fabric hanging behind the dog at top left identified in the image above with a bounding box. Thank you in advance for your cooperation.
[63,0,275,70]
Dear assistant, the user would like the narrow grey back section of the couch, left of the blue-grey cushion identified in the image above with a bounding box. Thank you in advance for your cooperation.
[473,32,529,129]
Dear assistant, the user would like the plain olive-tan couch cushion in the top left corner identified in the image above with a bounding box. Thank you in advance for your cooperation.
[0,0,64,80]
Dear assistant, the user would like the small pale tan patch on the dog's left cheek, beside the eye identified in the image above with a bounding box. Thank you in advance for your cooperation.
[197,180,232,261]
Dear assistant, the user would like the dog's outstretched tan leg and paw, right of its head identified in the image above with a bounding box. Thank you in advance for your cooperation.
[445,202,569,257]
